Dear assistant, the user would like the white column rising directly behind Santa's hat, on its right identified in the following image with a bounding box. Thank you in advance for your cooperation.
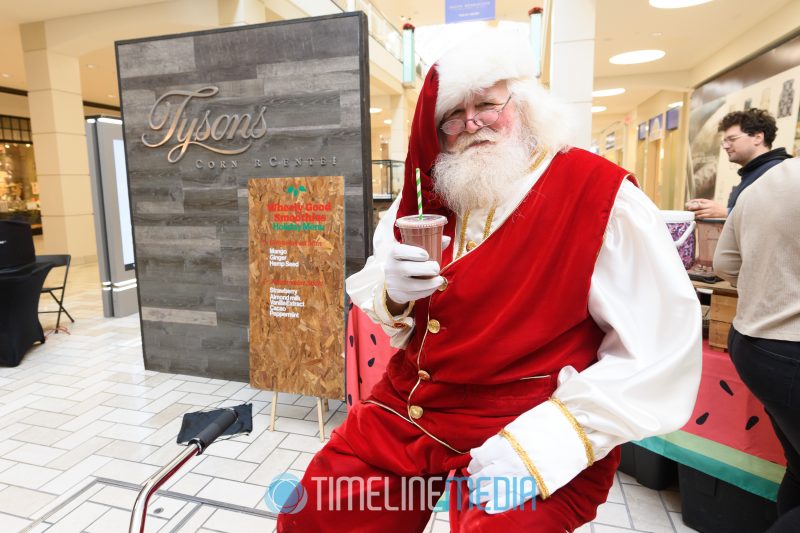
[549,0,597,149]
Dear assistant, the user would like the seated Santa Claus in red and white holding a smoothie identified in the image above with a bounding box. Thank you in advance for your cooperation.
[278,32,701,533]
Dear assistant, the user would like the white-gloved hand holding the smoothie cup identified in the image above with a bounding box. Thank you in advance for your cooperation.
[383,236,450,304]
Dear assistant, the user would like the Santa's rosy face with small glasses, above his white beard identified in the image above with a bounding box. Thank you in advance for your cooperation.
[442,81,520,153]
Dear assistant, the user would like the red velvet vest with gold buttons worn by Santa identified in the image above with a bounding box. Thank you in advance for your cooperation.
[372,149,627,451]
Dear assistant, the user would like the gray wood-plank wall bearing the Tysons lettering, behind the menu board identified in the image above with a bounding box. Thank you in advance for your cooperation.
[117,13,372,381]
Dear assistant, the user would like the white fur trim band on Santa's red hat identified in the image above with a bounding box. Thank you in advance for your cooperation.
[435,30,536,123]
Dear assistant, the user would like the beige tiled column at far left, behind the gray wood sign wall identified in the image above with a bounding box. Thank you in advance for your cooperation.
[20,22,97,264]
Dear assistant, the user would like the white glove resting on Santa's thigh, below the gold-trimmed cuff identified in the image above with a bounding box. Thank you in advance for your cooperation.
[467,435,539,514]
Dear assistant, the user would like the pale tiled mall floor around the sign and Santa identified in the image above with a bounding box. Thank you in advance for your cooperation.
[0,265,692,533]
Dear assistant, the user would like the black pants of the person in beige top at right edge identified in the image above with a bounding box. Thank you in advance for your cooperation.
[728,328,800,531]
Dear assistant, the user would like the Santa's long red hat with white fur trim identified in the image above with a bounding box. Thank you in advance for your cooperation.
[395,30,536,258]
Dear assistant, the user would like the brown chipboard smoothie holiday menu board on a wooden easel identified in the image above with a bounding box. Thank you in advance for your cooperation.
[248,176,345,398]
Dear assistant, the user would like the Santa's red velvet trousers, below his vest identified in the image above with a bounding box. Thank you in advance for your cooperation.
[278,403,619,533]
